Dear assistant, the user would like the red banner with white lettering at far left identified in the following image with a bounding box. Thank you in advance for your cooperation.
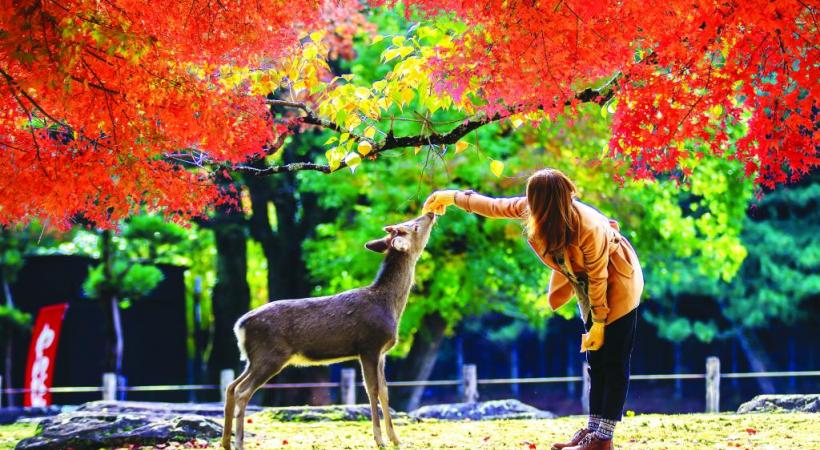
[23,303,68,406]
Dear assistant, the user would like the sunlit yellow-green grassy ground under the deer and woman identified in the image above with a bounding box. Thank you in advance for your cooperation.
[0,413,820,450]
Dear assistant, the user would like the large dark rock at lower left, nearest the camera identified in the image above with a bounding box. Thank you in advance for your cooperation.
[16,402,222,450]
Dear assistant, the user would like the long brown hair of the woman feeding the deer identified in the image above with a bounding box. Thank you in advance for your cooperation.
[527,169,578,254]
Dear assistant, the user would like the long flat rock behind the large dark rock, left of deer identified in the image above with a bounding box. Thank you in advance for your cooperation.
[77,401,262,418]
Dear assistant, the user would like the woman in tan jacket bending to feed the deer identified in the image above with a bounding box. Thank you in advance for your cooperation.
[424,169,643,450]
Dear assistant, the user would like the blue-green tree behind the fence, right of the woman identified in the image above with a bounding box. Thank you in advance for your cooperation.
[647,175,820,393]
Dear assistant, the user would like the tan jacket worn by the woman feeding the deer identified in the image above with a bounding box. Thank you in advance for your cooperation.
[455,192,643,324]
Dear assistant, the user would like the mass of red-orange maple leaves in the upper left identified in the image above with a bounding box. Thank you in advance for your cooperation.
[0,0,320,227]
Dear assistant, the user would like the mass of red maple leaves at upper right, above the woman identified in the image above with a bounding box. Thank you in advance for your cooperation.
[390,0,820,187]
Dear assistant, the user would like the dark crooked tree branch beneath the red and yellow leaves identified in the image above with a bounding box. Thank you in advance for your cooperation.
[243,73,621,176]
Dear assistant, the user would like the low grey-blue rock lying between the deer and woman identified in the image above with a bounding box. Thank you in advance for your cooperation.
[410,399,555,420]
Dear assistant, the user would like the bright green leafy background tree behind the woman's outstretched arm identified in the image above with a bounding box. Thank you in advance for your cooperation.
[300,96,751,406]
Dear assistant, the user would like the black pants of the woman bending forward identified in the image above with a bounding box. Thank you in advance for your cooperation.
[585,308,638,421]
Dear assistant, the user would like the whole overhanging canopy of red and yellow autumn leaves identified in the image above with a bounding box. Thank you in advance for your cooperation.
[0,0,820,227]
